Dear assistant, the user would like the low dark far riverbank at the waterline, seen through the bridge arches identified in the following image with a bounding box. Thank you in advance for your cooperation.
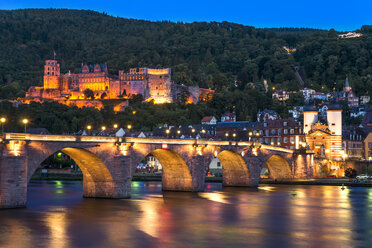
[32,174,372,187]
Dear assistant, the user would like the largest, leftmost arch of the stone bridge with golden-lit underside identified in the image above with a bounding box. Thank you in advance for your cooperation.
[27,147,115,198]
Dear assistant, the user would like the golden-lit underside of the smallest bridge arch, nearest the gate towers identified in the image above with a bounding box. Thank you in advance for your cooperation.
[262,154,292,179]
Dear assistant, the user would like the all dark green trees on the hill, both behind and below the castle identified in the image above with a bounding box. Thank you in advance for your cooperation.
[0,9,372,133]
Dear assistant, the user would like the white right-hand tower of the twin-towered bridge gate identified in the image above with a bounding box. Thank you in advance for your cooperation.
[327,103,342,160]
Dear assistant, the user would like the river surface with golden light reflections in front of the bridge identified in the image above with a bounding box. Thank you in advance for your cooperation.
[0,181,372,247]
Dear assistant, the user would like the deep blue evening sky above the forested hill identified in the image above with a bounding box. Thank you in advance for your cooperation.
[0,0,372,31]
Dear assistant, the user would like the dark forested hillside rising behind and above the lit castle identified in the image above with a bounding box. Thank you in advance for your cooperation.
[0,9,372,98]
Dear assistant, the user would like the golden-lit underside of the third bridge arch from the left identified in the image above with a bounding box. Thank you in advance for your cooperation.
[217,150,250,186]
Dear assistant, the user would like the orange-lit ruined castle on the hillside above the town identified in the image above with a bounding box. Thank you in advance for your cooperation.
[26,59,214,109]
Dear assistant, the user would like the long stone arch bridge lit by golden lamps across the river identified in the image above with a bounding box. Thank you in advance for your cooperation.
[0,133,314,208]
